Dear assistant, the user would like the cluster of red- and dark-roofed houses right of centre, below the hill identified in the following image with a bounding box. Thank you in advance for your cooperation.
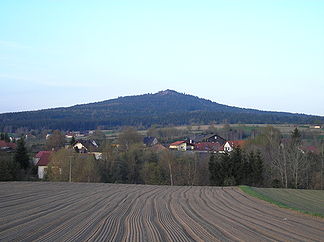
[169,134,245,153]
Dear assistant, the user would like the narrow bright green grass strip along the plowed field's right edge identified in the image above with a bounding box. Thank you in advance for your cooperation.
[239,185,324,218]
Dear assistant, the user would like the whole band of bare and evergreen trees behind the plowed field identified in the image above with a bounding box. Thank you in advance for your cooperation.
[0,126,324,189]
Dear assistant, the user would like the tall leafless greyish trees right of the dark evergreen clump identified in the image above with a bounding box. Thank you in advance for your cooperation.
[247,126,324,189]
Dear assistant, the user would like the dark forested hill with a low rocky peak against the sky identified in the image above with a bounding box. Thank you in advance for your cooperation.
[0,90,324,130]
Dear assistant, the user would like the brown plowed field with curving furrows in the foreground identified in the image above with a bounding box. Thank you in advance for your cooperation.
[0,182,324,241]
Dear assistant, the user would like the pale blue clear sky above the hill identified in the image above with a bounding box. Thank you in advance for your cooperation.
[0,0,324,116]
